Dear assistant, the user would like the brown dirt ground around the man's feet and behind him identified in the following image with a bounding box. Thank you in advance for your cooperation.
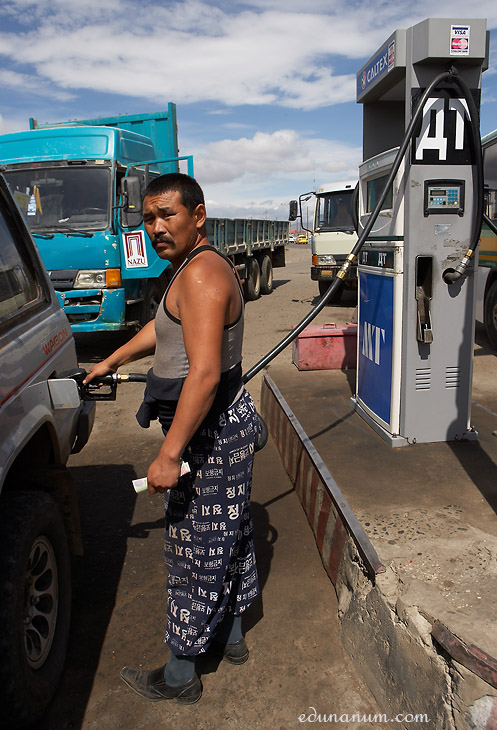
[32,246,497,730]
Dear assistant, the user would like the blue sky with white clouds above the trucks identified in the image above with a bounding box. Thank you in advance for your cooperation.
[0,0,497,219]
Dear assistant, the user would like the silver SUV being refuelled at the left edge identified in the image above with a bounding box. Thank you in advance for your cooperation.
[0,169,95,730]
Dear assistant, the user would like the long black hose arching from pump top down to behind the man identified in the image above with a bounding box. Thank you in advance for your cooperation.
[243,67,466,383]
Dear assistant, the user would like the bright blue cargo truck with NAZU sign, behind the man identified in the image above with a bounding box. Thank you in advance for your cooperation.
[0,103,288,332]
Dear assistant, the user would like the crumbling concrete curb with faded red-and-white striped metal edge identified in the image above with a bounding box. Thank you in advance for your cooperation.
[261,374,497,730]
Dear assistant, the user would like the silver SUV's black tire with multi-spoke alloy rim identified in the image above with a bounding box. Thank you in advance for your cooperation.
[0,491,71,730]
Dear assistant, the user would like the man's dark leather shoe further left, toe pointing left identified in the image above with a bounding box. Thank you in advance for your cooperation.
[121,667,202,705]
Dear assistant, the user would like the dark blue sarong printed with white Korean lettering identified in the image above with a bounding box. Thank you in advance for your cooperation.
[164,390,259,655]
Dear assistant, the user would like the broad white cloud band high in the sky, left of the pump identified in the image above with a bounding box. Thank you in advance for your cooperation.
[0,13,360,109]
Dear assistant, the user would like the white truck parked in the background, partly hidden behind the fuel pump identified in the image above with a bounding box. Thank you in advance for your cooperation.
[311,180,357,304]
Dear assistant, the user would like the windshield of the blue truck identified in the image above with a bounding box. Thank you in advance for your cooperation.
[5,165,110,233]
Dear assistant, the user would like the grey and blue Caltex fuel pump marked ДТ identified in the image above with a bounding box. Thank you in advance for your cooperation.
[353,18,489,446]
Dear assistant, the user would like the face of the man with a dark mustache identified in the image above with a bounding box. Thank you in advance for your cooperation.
[143,190,205,266]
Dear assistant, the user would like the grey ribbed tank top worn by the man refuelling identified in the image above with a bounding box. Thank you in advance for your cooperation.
[153,246,244,381]
